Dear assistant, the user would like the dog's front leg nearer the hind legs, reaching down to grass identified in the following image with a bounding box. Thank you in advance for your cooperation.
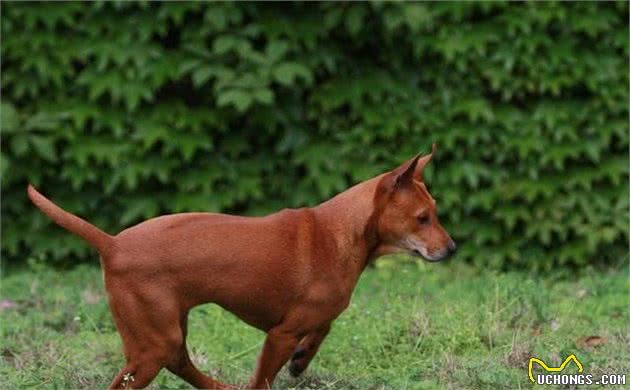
[247,326,299,389]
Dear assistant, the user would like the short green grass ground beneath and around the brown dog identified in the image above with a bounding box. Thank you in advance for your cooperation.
[0,261,630,389]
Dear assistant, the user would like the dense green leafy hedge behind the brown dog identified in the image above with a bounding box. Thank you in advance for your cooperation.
[1,2,629,270]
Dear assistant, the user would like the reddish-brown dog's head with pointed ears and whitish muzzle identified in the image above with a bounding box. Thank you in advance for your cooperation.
[376,144,457,261]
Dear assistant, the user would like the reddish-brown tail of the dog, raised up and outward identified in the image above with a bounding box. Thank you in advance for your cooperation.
[27,184,114,257]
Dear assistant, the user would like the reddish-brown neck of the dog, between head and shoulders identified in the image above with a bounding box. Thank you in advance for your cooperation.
[312,175,384,276]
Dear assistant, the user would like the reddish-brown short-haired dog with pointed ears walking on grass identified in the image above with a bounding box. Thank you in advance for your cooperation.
[28,145,455,389]
